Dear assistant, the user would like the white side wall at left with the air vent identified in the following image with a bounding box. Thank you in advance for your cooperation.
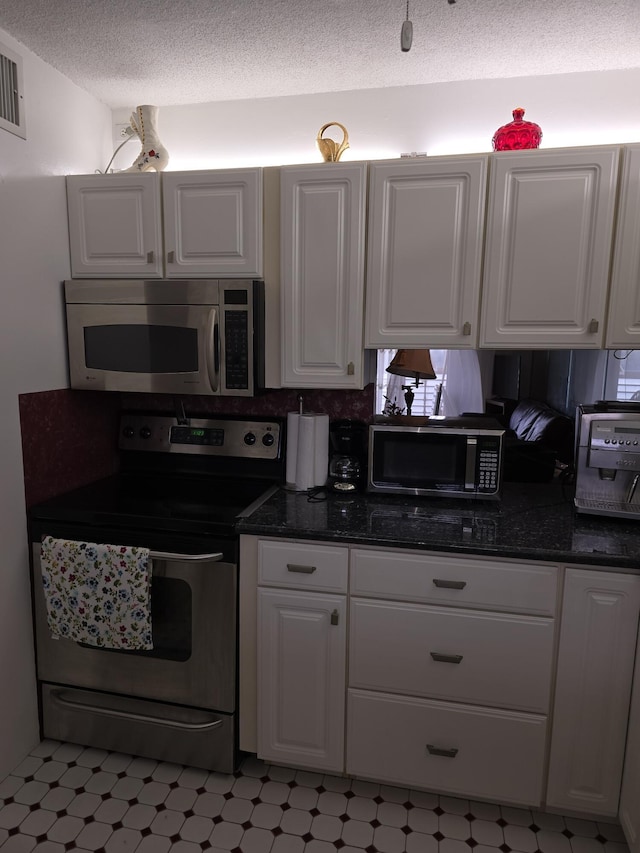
[0,30,111,779]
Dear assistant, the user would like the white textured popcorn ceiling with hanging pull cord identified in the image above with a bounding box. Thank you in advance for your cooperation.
[0,0,640,108]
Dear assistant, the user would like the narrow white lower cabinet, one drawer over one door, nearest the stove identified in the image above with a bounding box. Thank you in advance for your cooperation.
[257,541,347,773]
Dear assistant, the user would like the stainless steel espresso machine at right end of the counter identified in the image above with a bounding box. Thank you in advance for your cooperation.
[574,400,640,519]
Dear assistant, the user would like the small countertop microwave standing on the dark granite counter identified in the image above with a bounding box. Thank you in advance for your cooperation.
[367,416,504,500]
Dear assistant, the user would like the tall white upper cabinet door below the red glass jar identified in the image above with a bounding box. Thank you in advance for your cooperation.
[480,147,618,349]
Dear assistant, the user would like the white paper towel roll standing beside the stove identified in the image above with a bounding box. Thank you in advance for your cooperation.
[286,412,329,492]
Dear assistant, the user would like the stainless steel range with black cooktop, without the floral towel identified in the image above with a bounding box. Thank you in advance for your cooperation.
[29,414,284,772]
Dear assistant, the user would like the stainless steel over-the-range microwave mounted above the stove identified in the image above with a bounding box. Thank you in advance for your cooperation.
[64,279,264,397]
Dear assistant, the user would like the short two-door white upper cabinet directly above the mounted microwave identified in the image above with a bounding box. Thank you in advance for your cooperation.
[67,168,263,278]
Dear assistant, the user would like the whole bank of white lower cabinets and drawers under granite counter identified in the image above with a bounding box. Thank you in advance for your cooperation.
[252,538,640,812]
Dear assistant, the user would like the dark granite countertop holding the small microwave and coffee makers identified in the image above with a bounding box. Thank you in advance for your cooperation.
[237,481,640,572]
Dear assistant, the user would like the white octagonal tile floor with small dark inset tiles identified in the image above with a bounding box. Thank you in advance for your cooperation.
[0,740,628,853]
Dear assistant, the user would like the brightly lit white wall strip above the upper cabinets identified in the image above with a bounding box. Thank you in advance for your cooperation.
[113,69,640,169]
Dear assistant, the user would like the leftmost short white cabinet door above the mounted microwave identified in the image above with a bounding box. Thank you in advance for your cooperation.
[67,172,162,278]
